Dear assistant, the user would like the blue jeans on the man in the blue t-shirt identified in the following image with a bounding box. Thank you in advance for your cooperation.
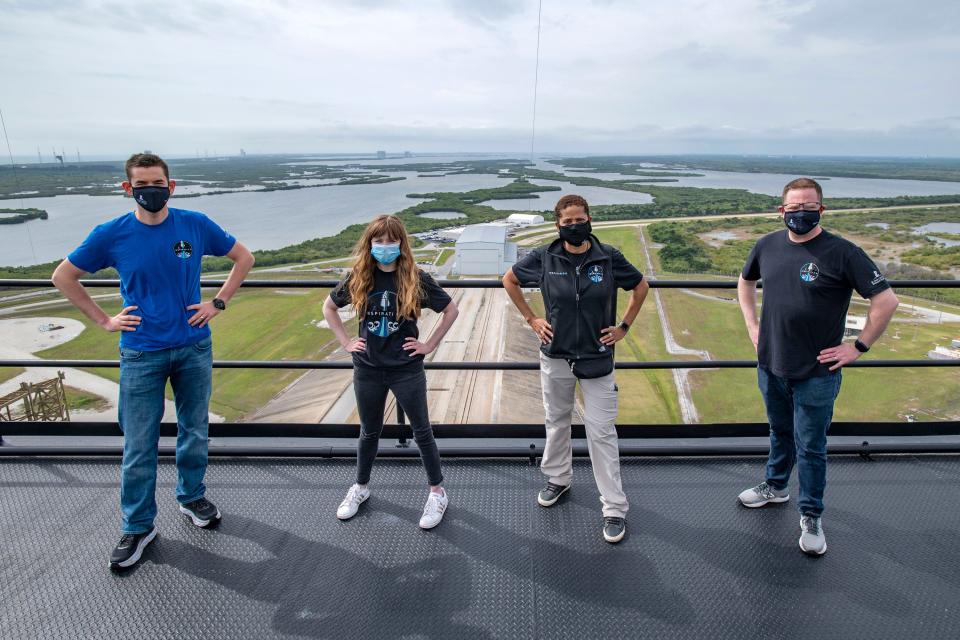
[119,338,213,533]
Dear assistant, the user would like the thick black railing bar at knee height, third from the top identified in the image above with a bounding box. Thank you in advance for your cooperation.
[0,421,960,439]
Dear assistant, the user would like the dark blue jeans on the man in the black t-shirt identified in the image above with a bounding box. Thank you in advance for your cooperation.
[757,367,842,517]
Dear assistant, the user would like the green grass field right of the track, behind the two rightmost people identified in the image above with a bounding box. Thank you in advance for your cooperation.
[584,220,960,422]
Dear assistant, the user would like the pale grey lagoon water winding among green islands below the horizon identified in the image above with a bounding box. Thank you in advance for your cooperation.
[0,155,960,266]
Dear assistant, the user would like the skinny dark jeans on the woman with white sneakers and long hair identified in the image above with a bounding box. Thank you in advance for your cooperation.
[353,366,443,485]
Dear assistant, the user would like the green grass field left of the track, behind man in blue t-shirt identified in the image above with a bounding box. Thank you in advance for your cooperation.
[18,289,344,420]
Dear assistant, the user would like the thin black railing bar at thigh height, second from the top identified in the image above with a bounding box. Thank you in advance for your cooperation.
[0,359,960,371]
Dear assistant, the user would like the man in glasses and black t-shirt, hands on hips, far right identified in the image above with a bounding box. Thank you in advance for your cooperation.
[737,178,899,555]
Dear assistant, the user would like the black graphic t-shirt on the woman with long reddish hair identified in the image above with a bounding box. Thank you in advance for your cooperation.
[330,268,450,368]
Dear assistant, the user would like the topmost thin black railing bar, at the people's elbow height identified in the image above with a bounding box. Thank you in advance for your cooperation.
[0,278,960,289]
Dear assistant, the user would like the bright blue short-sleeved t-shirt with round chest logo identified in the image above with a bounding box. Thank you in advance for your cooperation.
[67,208,237,351]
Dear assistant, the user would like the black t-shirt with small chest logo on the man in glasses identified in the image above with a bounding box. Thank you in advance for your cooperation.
[741,229,890,379]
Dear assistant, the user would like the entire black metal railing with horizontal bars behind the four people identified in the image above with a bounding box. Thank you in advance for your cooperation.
[0,279,960,459]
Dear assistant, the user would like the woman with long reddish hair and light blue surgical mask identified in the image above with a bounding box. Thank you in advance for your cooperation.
[323,215,458,529]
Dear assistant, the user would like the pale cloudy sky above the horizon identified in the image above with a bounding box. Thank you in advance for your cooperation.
[0,0,960,157]
